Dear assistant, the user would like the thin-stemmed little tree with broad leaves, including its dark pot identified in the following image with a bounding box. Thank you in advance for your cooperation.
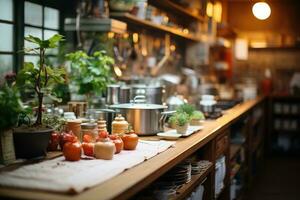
[14,34,65,158]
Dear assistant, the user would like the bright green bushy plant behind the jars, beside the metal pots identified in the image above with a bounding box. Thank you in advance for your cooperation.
[66,51,114,107]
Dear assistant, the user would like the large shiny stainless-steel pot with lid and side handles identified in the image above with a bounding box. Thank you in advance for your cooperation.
[110,96,175,135]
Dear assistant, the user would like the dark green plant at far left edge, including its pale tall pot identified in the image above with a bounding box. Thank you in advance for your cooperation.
[0,74,23,165]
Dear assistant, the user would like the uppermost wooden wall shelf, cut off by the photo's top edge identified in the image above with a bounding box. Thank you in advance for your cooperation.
[148,0,206,22]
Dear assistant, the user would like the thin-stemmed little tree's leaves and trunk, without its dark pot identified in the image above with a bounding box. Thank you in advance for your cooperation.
[17,34,65,126]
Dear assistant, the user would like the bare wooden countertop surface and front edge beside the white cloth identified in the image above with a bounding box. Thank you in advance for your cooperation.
[0,97,264,200]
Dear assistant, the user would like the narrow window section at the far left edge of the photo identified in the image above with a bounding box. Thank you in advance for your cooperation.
[0,0,15,82]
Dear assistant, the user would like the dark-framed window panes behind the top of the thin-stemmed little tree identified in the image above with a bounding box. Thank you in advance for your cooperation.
[24,1,59,63]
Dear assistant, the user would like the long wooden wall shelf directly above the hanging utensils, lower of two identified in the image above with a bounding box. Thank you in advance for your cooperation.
[110,12,203,42]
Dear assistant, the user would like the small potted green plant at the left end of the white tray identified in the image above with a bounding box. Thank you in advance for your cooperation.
[169,112,189,134]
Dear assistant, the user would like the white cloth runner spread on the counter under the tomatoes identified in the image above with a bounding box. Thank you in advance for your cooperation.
[0,140,175,193]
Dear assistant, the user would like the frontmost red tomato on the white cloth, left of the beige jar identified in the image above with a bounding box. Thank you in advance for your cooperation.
[63,142,81,161]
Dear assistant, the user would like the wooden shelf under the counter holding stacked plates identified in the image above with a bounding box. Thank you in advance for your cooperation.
[172,163,213,200]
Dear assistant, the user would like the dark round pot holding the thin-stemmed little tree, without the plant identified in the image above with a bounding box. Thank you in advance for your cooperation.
[13,127,53,159]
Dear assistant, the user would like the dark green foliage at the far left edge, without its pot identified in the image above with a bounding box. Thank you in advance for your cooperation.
[0,83,23,133]
